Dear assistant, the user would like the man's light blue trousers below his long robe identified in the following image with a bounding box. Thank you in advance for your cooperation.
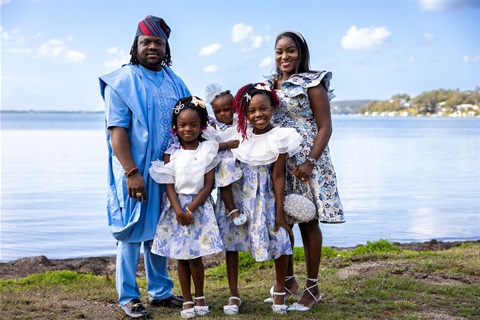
[115,241,173,306]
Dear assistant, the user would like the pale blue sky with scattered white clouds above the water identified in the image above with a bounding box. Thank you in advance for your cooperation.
[0,0,480,111]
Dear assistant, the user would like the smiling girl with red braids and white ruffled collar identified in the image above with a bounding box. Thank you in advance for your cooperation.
[232,83,302,314]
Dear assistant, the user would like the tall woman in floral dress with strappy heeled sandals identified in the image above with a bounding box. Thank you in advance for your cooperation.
[268,31,345,311]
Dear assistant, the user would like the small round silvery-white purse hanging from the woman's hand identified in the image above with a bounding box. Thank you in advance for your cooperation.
[283,178,317,223]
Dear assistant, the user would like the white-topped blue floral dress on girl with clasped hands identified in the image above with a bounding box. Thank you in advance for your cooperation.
[149,140,224,260]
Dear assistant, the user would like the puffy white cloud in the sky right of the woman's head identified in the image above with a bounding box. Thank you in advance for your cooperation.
[341,26,390,50]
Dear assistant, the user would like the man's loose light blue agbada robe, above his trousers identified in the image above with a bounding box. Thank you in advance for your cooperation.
[100,65,190,242]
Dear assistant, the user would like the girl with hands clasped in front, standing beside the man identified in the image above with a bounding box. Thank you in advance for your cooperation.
[149,96,224,318]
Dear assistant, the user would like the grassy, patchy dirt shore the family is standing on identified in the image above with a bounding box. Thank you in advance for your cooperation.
[0,239,480,320]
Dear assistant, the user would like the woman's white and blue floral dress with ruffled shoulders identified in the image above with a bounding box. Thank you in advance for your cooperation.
[268,71,345,223]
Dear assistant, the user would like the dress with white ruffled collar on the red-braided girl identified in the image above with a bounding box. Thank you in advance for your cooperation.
[232,128,302,261]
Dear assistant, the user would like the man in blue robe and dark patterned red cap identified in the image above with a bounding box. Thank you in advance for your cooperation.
[100,16,190,318]
